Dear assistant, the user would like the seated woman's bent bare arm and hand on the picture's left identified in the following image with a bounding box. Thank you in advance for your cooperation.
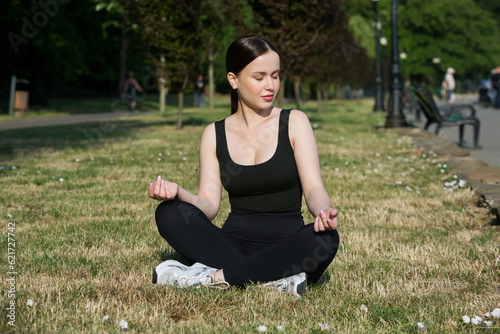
[148,124,222,220]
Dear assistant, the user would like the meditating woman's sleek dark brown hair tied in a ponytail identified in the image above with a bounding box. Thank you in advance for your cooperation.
[226,36,278,114]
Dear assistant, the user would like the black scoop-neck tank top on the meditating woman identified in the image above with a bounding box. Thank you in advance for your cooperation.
[215,109,302,214]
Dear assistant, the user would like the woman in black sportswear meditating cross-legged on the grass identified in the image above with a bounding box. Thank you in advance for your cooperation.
[148,36,339,297]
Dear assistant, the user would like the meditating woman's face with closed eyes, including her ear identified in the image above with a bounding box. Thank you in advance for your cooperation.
[228,51,280,110]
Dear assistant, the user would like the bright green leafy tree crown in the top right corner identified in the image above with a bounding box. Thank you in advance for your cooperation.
[400,0,500,81]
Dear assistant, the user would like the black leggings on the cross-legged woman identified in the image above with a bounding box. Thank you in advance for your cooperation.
[156,200,339,286]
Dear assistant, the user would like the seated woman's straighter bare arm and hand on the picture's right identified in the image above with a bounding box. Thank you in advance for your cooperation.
[289,110,338,232]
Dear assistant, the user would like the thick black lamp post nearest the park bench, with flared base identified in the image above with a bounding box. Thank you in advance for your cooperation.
[385,0,408,128]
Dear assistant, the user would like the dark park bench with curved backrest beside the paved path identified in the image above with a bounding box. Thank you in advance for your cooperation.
[414,86,480,149]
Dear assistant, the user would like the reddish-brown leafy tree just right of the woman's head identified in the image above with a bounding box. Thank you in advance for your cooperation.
[249,0,368,110]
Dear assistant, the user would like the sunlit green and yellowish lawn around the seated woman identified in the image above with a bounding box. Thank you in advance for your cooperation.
[0,100,500,333]
